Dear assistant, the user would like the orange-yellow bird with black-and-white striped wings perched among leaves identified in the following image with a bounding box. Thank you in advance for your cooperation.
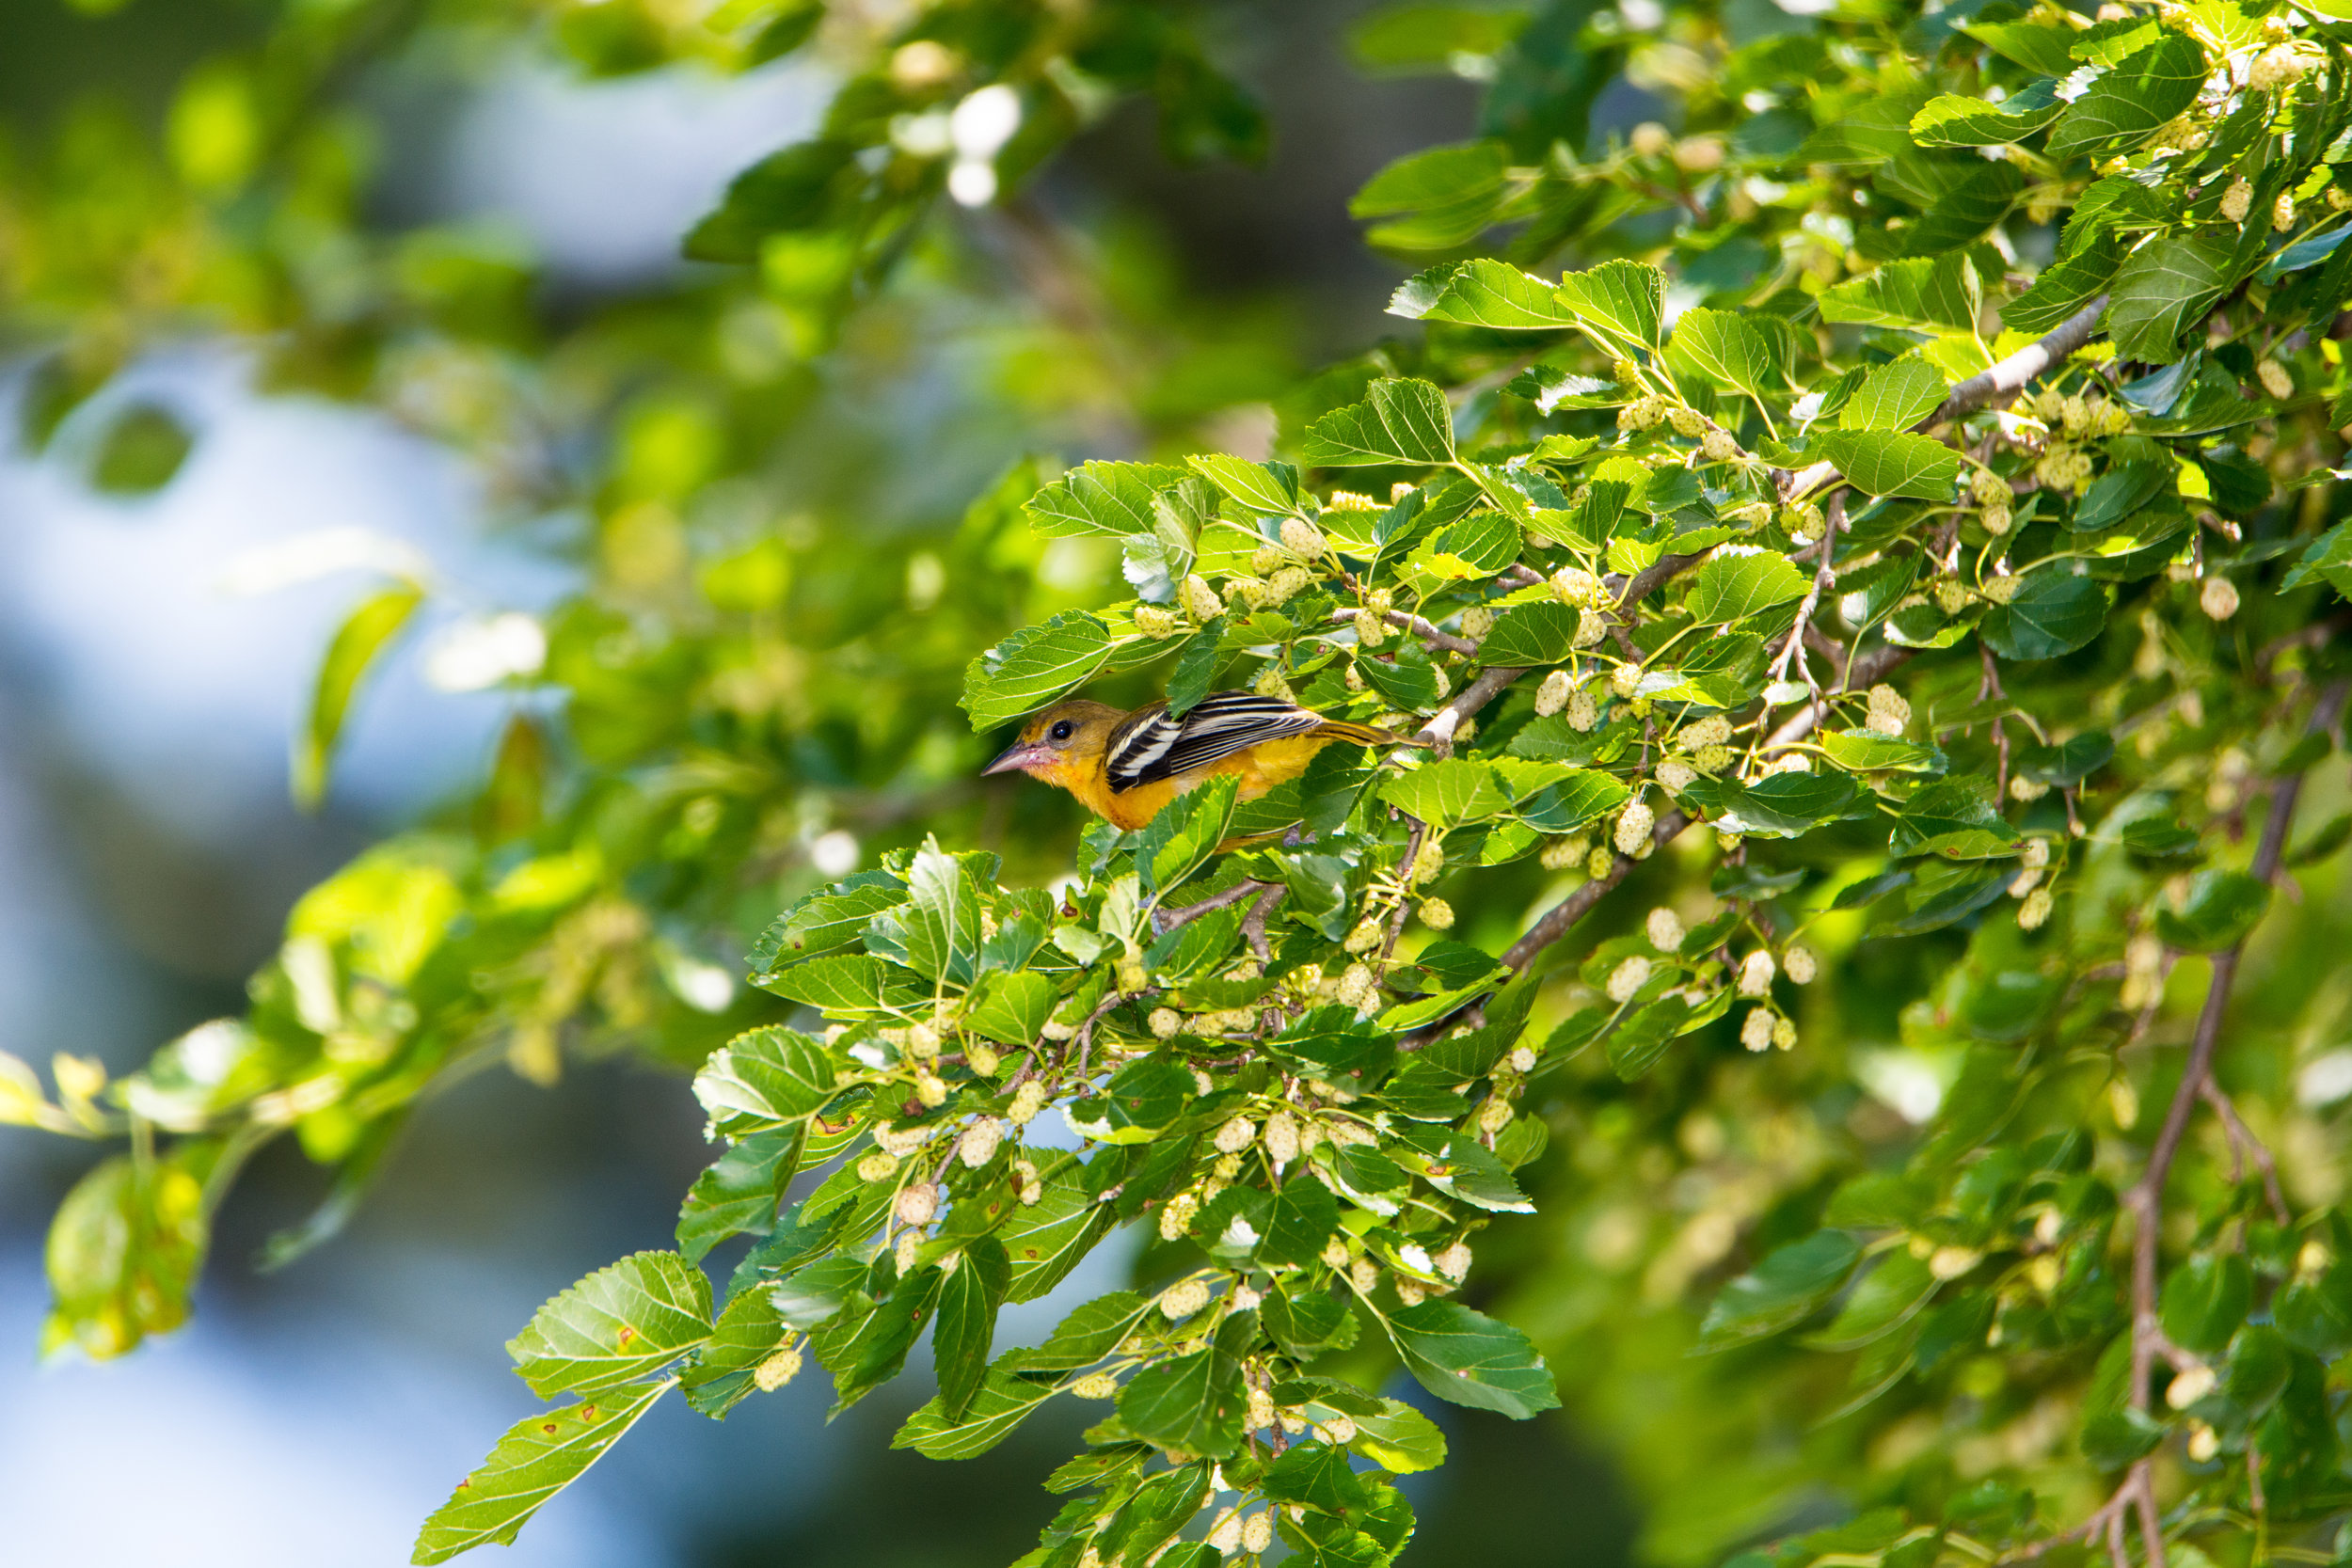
[983,691,1421,832]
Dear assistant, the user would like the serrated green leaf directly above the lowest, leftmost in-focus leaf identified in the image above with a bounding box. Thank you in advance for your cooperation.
[506,1253,710,1399]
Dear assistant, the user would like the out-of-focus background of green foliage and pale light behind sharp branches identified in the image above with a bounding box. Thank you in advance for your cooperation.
[13,0,2352,1566]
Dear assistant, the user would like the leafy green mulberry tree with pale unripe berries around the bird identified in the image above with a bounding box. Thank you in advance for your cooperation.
[13,0,2352,1568]
